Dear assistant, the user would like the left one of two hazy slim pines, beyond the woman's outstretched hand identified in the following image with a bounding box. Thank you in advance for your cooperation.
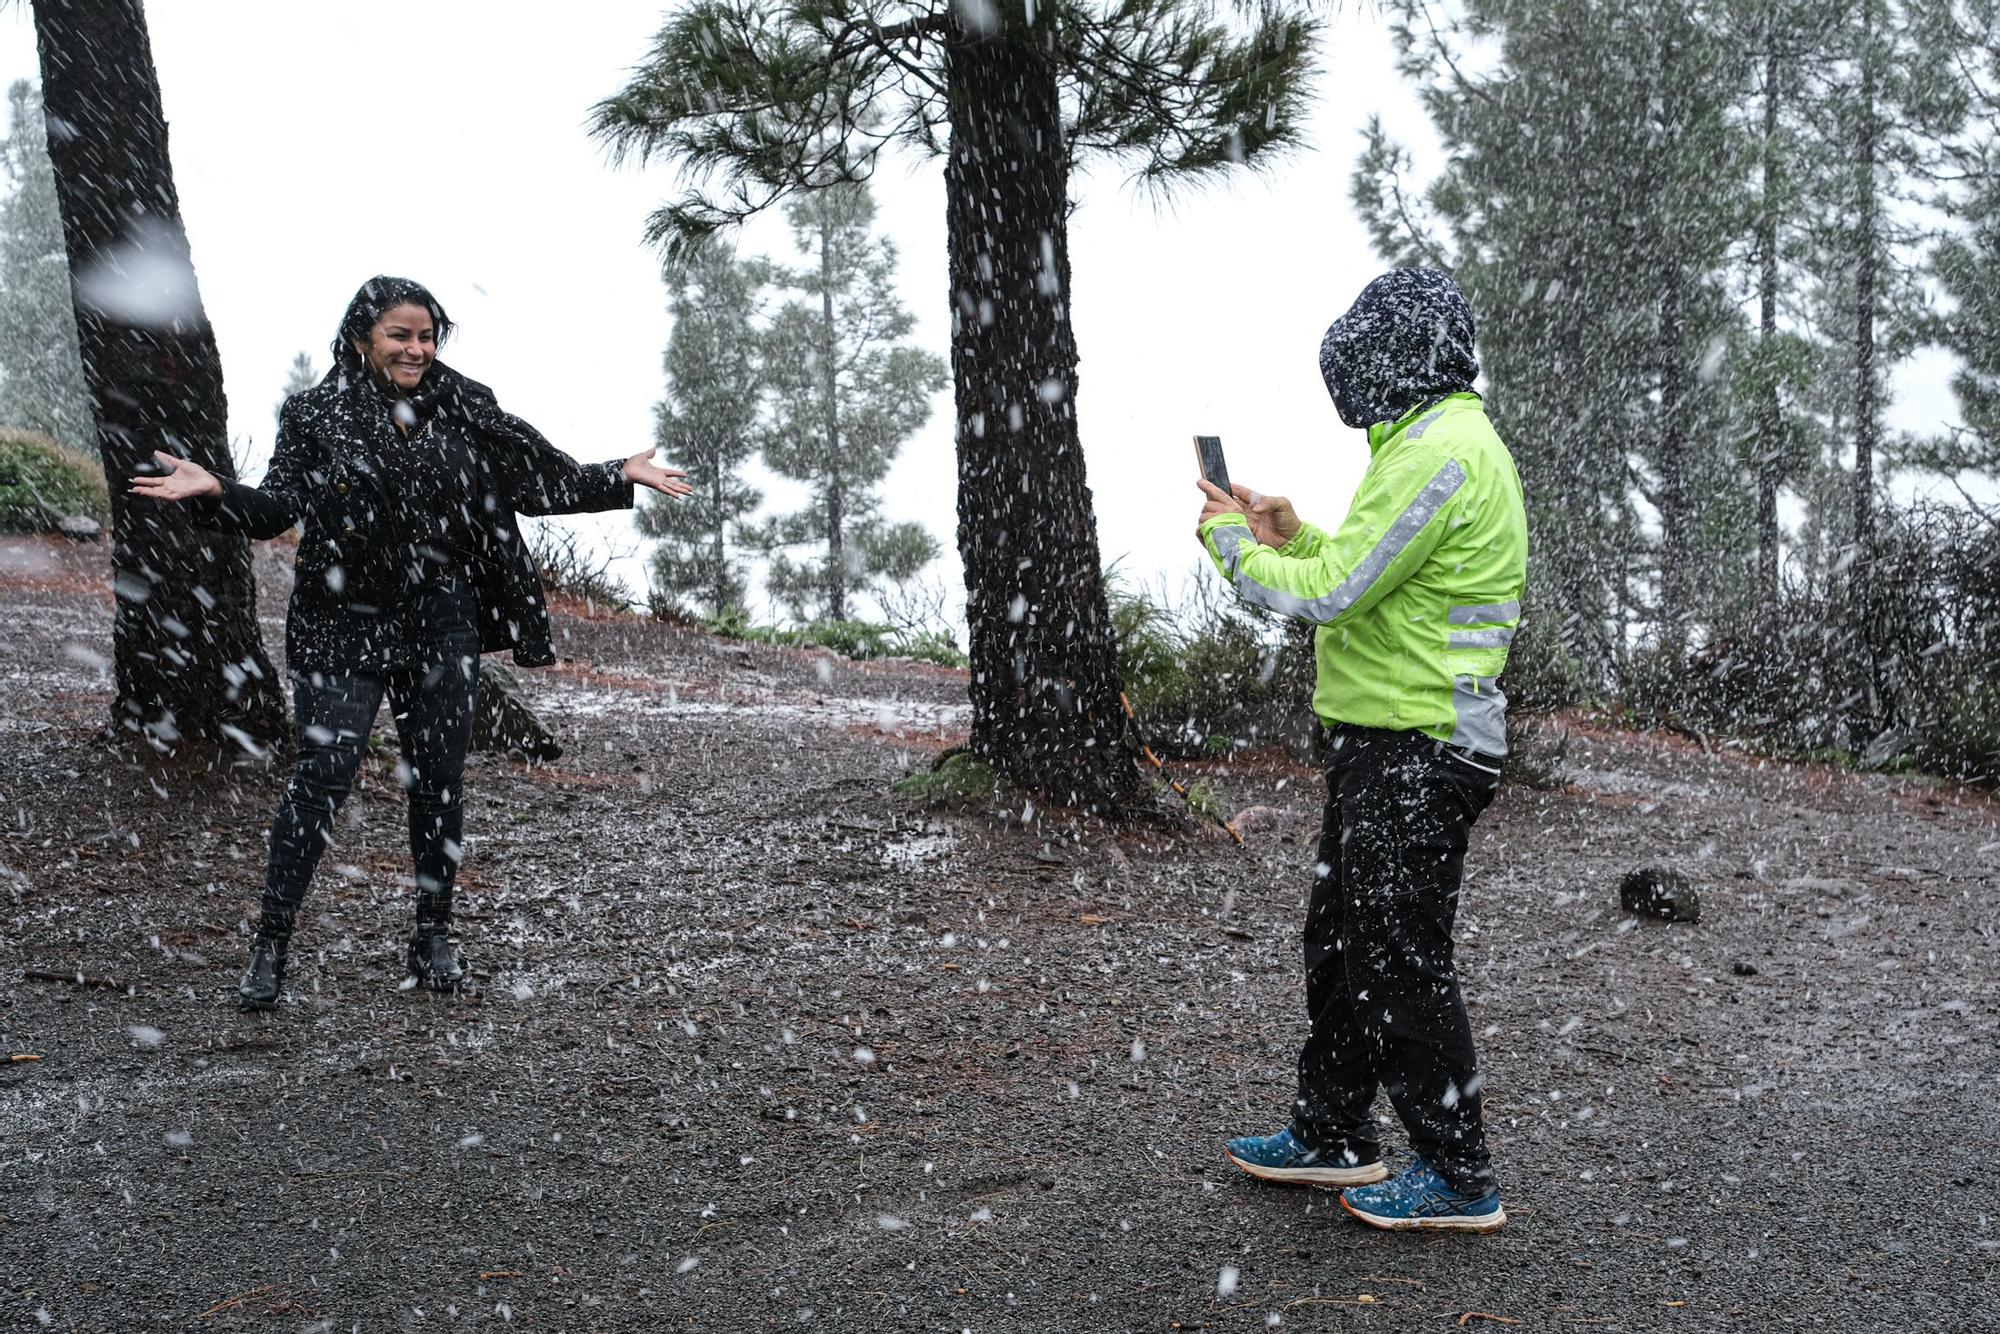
[636,240,764,616]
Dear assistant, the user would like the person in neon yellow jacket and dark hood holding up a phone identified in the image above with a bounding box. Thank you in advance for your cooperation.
[1200,268,1528,1232]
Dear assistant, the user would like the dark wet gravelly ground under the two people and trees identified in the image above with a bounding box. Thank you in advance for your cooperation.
[0,542,2000,1330]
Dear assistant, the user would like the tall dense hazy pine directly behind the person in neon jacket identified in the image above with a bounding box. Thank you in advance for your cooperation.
[1354,0,1746,684]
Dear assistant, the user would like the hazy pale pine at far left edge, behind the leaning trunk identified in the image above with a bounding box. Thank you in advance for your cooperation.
[0,80,96,452]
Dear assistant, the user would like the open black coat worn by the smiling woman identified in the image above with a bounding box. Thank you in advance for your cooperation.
[192,362,632,674]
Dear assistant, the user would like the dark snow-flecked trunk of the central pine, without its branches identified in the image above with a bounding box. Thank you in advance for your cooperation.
[944,20,1138,810]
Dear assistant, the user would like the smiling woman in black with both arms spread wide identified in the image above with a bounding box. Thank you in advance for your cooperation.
[132,278,690,1006]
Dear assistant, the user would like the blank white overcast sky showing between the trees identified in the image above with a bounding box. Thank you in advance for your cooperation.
[0,0,1954,628]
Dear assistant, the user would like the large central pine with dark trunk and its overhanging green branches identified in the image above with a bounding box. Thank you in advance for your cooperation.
[596,0,1316,810]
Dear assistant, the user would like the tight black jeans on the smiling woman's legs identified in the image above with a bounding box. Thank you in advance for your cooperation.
[262,580,480,938]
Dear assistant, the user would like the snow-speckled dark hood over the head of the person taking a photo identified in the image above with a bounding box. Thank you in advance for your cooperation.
[1320,268,1480,430]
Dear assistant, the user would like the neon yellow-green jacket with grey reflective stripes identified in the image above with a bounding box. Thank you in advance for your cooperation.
[1202,394,1528,756]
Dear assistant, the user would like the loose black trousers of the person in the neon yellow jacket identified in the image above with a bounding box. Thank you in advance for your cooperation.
[1292,726,1500,1194]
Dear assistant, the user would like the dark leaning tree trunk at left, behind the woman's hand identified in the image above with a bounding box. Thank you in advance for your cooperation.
[34,0,284,746]
